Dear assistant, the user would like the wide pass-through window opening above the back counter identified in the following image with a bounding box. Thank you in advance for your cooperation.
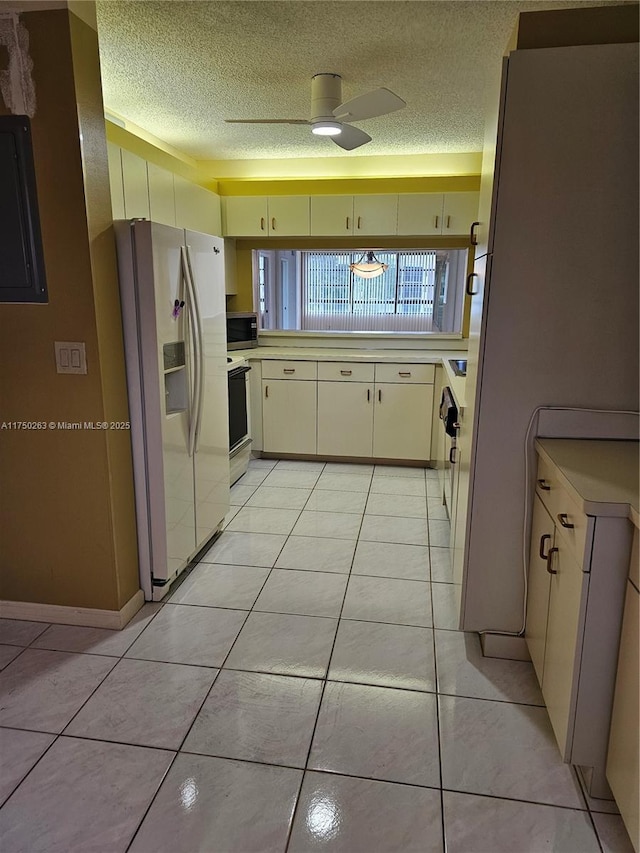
[254,249,467,333]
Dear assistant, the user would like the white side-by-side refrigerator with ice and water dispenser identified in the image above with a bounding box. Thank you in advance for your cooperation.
[115,220,229,601]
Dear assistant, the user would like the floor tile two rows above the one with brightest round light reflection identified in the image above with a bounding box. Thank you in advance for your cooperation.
[328,619,436,692]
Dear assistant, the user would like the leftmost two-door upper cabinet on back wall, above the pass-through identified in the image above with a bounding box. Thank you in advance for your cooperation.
[224,195,309,237]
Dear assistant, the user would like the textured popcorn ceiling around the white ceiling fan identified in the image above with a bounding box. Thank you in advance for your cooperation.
[97,0,628,160]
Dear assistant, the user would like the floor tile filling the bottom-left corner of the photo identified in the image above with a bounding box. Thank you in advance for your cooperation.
[0,736,173,853]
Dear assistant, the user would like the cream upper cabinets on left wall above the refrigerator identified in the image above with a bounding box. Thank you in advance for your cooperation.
[107,143,222,236]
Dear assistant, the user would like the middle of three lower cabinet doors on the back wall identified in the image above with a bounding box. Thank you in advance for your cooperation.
[318,382,373,456]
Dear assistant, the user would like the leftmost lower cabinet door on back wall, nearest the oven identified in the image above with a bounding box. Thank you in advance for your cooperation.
[262,379,317,454]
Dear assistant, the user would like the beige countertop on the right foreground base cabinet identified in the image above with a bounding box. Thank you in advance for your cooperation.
[536,438,640,527]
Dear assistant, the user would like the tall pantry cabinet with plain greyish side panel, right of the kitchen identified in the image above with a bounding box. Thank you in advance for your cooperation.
[454,41,638,633]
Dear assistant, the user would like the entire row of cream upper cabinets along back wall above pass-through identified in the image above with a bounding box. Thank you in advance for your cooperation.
[223,192,478,237]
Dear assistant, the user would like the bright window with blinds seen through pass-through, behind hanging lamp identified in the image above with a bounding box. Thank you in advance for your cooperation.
[301,251,442,332]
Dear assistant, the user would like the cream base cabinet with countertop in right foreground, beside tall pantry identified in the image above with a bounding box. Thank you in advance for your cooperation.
[525,439,638,796]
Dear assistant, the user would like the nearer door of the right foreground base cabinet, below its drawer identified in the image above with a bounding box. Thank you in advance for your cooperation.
[542,534,589,761]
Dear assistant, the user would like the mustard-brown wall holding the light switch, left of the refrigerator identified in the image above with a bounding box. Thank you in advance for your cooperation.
[0,5,139,610]
